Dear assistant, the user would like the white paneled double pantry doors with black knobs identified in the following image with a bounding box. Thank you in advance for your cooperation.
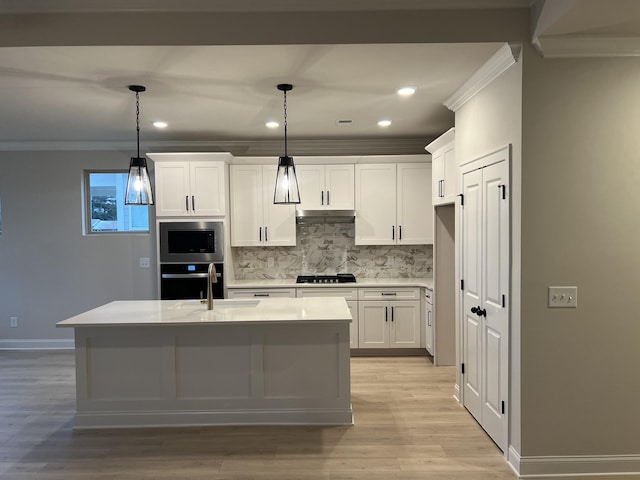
[461,148,510,451]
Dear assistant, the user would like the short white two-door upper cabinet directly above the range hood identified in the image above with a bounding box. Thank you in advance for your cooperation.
[296,164,354,210]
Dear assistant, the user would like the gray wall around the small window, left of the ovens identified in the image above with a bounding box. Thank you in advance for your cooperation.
[0,152,156,346]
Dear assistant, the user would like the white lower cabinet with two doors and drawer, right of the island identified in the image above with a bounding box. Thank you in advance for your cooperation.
[358,288,421,348]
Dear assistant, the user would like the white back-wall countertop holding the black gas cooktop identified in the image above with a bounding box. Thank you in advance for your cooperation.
[227,277,433,290]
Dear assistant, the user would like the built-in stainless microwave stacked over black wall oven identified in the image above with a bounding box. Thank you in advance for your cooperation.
[158,221,224,300]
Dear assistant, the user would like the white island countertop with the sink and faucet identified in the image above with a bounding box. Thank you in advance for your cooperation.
[57,297,351,327]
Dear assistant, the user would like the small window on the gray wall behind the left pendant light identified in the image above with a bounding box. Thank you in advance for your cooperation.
[84,171,149,233]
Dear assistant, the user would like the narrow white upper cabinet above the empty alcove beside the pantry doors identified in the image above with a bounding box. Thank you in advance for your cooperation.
[426,128,458,205]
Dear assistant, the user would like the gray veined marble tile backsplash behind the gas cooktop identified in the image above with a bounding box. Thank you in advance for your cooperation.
[231,223,433,280]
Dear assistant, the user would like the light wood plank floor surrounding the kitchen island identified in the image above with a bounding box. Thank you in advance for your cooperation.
[0,351,516,480]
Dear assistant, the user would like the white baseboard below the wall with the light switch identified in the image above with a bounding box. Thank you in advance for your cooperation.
[507,447,640,478]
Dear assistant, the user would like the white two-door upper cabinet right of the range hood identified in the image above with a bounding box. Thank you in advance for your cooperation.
[355,157,433,245]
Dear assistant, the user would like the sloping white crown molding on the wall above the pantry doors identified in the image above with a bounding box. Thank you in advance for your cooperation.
[443,43,520,112]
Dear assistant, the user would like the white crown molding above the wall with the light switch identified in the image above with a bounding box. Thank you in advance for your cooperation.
[538,35,640,58]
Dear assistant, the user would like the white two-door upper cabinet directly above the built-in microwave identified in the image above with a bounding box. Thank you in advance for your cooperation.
[148,153,231,217]
